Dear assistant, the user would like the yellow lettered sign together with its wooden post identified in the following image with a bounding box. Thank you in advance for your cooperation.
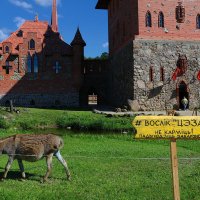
[133,116,200,200]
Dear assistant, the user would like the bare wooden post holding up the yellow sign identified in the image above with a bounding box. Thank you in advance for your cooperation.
[171,140,180,200]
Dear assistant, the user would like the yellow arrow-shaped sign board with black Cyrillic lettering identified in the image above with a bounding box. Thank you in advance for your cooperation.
[133,116,200,139]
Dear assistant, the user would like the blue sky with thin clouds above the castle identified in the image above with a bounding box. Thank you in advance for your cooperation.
[0,0,108,57]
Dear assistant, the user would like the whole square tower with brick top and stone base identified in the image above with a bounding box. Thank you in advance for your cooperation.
[96,0,200,110]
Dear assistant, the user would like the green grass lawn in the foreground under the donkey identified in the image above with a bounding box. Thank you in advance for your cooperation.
[0,131,200,200]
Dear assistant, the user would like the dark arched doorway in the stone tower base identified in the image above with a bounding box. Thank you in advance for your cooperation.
[178,81,189,110]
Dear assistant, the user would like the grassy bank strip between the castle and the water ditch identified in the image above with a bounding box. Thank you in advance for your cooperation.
[0,108,134,132]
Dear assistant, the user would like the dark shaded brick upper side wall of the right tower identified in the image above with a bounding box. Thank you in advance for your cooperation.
[108,0,138,55]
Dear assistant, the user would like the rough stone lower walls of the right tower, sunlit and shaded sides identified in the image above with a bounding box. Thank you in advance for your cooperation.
[110,40,200,110]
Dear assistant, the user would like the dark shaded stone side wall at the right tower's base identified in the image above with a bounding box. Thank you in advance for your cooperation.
[108,43,134,106]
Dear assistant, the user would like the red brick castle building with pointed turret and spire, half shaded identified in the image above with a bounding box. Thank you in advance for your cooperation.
[0,0,86,106]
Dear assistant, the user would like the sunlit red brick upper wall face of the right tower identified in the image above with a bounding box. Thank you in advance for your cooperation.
[137,0,200,40]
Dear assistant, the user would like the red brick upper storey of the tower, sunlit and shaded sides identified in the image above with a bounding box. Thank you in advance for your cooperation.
[108,0,200,55]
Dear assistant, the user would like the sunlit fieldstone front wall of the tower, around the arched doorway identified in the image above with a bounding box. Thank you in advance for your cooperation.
[134,40,200,110]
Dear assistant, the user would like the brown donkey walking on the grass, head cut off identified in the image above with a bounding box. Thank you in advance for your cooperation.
[0,134,70,181]
